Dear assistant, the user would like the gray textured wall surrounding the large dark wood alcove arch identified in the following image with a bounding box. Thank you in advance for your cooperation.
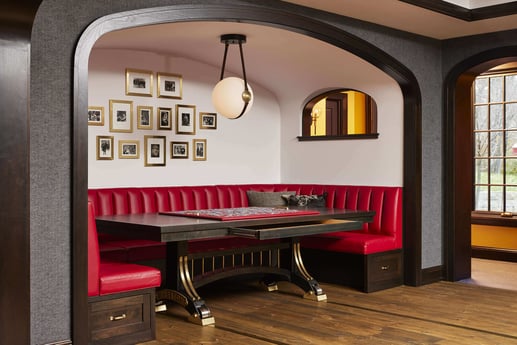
[30,0,442,344]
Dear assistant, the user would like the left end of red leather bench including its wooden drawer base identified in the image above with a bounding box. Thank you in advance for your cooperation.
[88,203,161,345]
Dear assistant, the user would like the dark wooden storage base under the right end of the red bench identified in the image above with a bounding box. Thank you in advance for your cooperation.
[302,248,403,292]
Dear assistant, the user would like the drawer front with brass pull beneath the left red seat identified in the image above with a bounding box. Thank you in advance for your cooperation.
[89,294,151,342]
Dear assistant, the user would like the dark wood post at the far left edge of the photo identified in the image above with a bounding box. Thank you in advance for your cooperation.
[0,1,39,344]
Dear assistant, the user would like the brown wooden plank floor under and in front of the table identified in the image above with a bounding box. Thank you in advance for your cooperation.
[139,258,517,345]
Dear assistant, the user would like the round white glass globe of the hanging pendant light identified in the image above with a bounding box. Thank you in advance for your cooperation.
[212,77,253,119]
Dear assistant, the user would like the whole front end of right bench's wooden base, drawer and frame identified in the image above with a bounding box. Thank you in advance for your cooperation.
[364,250,402,292]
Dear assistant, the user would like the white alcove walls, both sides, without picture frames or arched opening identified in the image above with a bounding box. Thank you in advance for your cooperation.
[88,48,403,188]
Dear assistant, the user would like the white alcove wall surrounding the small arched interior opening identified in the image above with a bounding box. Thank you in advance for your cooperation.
[279,52,404,186]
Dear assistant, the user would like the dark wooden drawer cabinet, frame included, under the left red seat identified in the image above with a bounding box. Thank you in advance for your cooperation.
[88,289,155,345]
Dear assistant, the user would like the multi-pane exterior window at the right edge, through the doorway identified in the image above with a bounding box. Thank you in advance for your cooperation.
[473,71,517,213]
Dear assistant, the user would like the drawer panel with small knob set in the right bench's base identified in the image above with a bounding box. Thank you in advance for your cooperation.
[368,252,402,283]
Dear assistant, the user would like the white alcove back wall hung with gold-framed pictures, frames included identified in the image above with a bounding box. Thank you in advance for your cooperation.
[85,49,281,188]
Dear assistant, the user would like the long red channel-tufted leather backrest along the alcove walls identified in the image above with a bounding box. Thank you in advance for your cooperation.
[88,184,402,246]
